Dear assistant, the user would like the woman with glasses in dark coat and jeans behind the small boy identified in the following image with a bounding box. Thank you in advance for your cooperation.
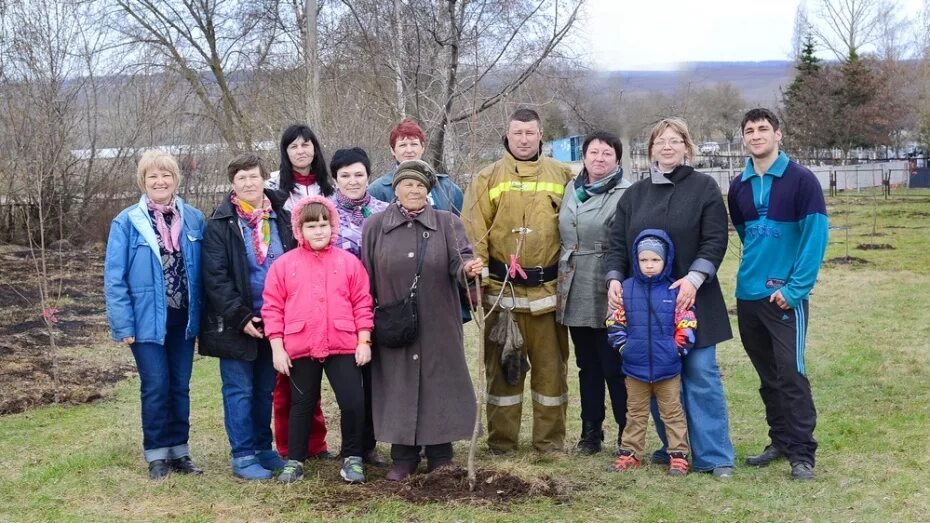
[607,118,734,479]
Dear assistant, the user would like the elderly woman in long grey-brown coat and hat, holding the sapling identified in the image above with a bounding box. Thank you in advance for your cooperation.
[362,160,482,481]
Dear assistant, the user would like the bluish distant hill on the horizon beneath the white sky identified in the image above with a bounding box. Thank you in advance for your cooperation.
[601,60,794,105]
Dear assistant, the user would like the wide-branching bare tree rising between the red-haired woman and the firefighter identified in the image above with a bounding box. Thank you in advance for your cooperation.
[334,0,584,170]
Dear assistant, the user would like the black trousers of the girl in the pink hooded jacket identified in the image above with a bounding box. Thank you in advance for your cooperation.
[288,354,365,461]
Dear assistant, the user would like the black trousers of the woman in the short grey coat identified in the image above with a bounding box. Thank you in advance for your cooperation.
[568,327,626,433]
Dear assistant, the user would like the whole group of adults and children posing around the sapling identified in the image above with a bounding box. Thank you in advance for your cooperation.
[105,108,827,483]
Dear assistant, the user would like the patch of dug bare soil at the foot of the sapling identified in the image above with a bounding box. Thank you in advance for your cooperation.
[327,467,571,507]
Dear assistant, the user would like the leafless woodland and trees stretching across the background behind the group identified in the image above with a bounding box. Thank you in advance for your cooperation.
[0,0,930,245]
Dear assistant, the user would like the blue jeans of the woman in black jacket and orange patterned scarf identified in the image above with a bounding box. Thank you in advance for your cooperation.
[220,340,275,458]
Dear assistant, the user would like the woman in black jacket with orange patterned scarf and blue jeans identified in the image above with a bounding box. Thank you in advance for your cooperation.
[200,154,295,480]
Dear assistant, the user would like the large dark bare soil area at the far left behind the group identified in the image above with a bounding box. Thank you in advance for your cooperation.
[0,246,135,415]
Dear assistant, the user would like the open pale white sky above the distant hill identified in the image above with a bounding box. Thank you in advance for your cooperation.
[582,0,921,71]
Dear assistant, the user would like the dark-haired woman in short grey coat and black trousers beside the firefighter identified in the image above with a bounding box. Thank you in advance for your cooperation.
[556,131,630,454]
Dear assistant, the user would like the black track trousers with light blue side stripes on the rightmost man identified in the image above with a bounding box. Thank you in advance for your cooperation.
[736,299,817,465]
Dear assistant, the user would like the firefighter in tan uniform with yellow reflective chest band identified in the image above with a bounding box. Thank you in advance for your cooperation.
[462,109,572,453]
